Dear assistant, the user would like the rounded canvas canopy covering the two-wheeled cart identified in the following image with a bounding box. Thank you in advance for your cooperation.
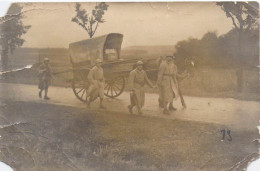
[69,33,123,65]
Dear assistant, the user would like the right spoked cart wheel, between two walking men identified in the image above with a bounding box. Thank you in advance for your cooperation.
[104,77,125,98]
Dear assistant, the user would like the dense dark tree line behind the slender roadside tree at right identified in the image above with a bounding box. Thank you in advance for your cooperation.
[175,28,259,68]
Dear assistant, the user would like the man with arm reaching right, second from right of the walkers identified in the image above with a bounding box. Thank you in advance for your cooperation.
[128,61,154,114]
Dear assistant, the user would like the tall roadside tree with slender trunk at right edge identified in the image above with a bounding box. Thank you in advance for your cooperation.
[216,2,259,92]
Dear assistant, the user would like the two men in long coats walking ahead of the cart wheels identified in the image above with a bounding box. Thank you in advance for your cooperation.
[128,56,179,114]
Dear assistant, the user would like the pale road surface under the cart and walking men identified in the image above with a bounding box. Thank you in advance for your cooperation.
[0,83,260,130]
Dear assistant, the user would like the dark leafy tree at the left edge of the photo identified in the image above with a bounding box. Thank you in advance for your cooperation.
[0,3,31,70]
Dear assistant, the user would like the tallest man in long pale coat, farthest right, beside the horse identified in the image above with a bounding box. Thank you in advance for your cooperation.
[157,56,178,114]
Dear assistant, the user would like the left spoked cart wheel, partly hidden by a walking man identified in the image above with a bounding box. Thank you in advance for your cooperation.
[72,72,88,103]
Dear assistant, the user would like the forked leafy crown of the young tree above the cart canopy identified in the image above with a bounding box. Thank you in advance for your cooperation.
[71,2,108,38]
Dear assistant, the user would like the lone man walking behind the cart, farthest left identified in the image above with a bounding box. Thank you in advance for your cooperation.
[38,58,52,100]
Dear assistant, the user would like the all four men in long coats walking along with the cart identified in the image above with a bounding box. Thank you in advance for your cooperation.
[39,56,183,114]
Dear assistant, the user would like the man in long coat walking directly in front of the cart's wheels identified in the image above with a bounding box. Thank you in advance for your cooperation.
[86,59,105,109]
